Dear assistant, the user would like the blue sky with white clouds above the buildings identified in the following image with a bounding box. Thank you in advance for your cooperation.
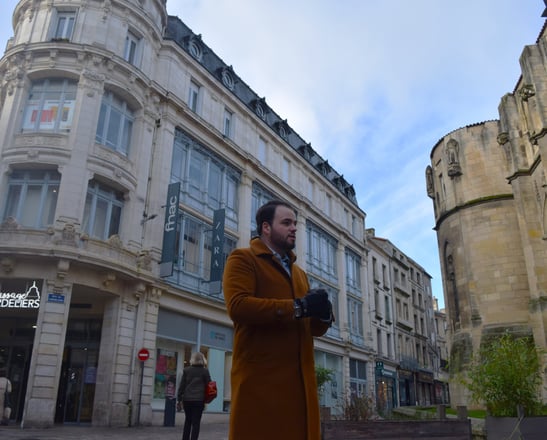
[0,0,545,307]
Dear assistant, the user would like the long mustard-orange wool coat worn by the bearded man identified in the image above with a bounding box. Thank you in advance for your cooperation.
[223,238,328,440]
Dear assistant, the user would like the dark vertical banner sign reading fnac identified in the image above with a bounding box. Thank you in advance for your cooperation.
[160,182,180,277]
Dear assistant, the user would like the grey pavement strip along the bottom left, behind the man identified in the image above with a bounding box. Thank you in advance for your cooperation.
[0,413,228,440]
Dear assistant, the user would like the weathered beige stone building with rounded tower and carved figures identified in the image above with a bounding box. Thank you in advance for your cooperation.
[426,19,547,405]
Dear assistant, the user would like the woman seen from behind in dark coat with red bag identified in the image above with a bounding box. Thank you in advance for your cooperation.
[177,352,211,440]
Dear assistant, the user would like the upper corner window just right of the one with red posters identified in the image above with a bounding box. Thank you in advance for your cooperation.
[95,92,135,155]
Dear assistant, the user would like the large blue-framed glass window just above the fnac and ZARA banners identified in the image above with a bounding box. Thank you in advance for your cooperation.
[171,130,240,229]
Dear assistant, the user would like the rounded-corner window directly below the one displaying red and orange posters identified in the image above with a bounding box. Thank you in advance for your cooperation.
[3,170,61,228]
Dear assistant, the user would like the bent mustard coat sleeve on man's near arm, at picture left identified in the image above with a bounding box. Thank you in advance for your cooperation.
[223,249,294,325]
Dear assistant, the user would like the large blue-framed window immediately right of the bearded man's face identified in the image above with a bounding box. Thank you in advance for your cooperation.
[306,222,338,282]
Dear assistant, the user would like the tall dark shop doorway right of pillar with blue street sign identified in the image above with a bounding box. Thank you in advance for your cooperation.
[55,319,101,424]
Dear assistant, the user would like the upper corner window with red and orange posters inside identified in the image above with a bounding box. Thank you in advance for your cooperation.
[23,78,77,132]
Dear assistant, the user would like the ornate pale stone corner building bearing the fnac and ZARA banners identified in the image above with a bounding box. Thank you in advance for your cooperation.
[0,0,375,426]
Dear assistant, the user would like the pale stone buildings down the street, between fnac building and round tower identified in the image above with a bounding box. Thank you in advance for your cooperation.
[366,228,450,408]
